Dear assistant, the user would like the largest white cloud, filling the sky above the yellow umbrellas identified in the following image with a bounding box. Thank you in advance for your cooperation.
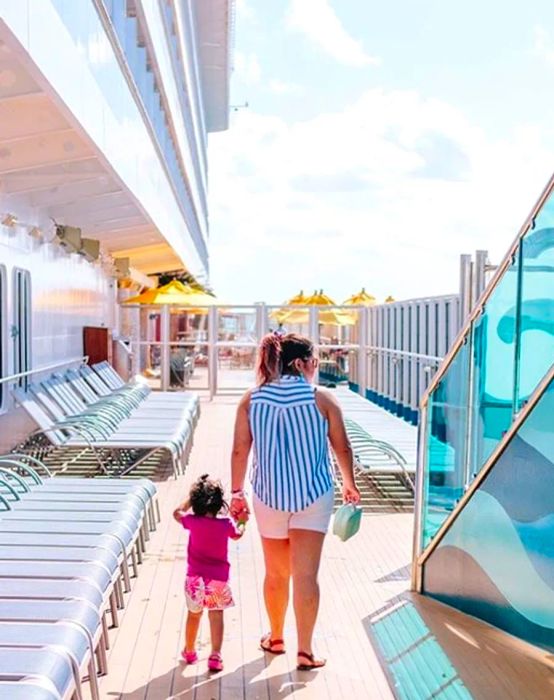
[210,90,554,303]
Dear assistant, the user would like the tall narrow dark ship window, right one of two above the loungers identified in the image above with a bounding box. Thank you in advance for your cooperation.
[12,268,31,389]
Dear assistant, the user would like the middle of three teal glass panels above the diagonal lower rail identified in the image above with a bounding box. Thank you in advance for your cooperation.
[468,255,519,483]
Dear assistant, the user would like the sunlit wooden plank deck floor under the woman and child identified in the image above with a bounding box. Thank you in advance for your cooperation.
[87,397,554,700]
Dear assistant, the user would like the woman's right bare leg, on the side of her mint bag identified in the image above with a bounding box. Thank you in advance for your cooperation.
[289,529,325,654]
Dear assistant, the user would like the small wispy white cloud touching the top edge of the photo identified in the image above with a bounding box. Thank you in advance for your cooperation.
[286,0,380,67]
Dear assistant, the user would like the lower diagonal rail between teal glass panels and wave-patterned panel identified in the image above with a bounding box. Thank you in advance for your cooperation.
[413,364,554,583]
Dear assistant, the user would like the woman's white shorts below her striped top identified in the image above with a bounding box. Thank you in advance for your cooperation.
[253,488,335,540]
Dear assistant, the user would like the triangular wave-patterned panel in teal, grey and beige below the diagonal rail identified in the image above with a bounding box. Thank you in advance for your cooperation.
[423,372,554,651]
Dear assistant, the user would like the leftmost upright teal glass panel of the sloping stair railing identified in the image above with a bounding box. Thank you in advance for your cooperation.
[421,333,471,547]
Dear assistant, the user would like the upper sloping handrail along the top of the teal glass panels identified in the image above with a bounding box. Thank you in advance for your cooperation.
[421,175,554,407]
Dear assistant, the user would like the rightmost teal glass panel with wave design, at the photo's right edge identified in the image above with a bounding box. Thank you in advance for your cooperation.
[512,195,554,411]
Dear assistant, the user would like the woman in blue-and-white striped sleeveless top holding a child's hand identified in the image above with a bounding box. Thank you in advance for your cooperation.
[227,333,360,670]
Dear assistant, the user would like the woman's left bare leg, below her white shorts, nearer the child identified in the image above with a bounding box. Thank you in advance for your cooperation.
[262,537,290,651]
